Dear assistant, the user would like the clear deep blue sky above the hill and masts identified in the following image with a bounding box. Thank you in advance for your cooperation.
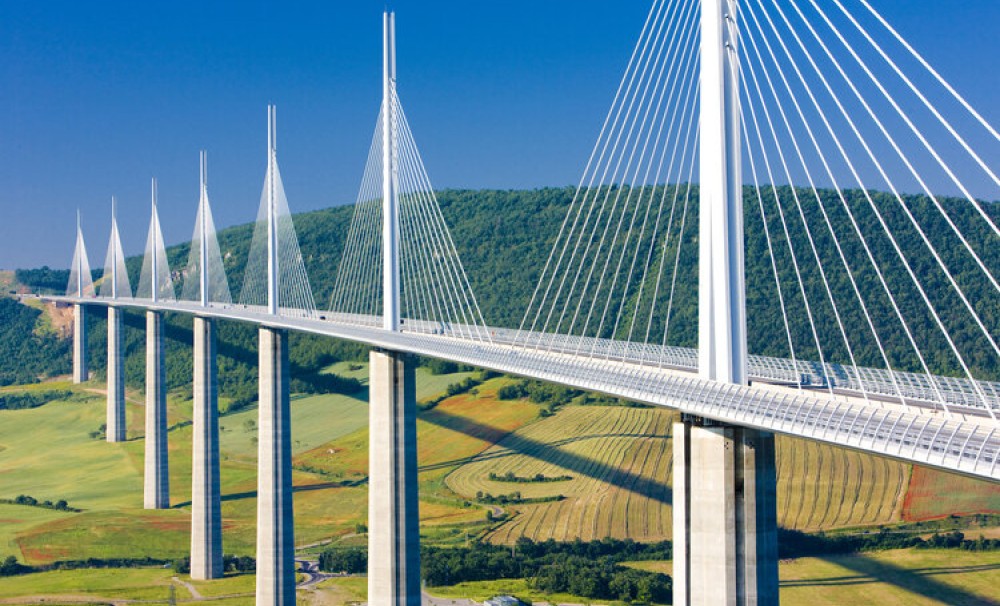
[0,0,1000,268]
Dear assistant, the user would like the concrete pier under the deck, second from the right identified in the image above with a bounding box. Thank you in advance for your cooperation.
[368,351,420,606]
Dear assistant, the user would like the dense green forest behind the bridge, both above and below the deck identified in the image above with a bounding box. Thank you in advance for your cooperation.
[7,185,1000,388]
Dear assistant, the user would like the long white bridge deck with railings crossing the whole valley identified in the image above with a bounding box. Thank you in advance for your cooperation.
[56,297,1000,481]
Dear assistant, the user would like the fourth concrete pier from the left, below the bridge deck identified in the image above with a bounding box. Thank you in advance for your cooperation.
[191,317,223,580]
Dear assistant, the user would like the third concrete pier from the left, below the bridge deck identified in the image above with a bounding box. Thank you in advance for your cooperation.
[143,311,170,509]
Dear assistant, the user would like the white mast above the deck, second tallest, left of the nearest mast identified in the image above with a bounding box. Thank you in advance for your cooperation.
[382,12,399,331]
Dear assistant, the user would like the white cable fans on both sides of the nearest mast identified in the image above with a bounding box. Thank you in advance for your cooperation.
[516,0,1000,415]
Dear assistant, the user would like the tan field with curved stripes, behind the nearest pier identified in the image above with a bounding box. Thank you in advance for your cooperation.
[446,406,909,543]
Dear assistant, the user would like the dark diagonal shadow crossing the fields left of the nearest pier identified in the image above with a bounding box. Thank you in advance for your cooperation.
[418,408,673,505]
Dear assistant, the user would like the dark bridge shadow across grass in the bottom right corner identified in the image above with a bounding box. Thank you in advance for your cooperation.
[781,555,1000,606]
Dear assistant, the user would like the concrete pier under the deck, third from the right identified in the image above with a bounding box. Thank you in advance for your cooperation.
[257,327,295,606]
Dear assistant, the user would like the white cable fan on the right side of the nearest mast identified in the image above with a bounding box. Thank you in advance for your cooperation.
[734,0,1000,416]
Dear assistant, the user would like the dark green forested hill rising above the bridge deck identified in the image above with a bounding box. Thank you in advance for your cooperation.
[9,186,1000,390]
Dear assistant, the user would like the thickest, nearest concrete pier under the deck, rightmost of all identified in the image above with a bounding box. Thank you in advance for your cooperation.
[673,417,778,606]
